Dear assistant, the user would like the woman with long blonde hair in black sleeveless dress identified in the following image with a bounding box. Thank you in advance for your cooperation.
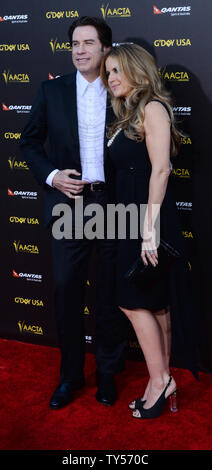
[101,44,198,418]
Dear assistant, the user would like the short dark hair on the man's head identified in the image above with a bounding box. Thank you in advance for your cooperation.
[68,16,112,47]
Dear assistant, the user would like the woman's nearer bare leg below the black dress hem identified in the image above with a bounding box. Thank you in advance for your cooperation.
[120,307,176,413]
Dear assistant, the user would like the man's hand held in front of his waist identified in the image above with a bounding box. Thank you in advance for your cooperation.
[52,170,88,199]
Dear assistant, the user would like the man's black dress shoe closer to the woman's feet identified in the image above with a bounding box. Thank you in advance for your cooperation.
[96,374,117,406]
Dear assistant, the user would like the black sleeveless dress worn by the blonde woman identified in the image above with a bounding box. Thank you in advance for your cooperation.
[109,103,197,375]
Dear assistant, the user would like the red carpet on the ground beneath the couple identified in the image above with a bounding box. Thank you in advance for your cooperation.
[0,340,212,450]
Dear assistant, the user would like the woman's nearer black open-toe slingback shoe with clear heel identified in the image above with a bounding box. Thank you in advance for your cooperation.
[133,376,178,419]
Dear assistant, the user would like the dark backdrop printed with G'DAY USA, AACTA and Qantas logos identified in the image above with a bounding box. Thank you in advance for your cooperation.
[0,0,212,371]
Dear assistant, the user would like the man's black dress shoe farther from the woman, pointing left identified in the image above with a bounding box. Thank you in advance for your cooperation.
[49,381,84,410]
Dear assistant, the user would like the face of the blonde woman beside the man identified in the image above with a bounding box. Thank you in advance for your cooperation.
[105,56,132,98]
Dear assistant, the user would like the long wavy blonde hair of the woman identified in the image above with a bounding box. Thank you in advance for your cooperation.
[100,44,182,155]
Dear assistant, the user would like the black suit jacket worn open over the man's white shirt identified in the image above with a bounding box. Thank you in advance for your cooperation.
[20,72,114,226]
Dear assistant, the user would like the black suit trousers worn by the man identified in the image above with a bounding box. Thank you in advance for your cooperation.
[52,191,127,386]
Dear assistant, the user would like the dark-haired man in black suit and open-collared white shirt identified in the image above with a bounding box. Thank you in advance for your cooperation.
[21,17,125,409]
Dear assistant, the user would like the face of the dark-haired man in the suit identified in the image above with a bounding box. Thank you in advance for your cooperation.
[72,26,109,82]
